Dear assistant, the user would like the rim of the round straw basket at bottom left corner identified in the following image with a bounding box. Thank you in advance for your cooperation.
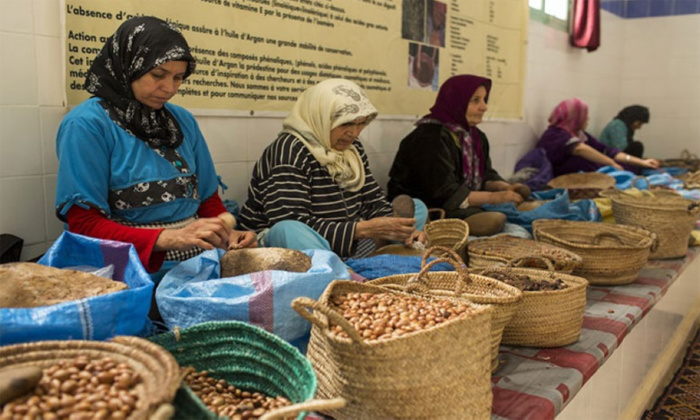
[0,336,181,419]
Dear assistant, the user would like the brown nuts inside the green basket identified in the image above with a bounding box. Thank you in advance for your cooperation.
[181,366,292,420]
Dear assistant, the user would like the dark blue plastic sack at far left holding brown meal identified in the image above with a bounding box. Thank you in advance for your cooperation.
[0,232,153,345]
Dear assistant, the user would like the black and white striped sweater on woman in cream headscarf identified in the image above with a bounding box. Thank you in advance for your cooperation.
[239,133,392,257]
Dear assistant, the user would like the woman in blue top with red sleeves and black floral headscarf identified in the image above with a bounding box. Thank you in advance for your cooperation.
[56,17,256,281]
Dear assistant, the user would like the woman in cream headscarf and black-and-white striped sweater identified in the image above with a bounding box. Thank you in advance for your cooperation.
[240,79,427,257]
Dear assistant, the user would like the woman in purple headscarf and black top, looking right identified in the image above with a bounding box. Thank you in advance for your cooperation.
[388,75,530,236]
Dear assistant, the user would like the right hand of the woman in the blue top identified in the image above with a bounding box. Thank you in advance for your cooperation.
[154,217,232,251]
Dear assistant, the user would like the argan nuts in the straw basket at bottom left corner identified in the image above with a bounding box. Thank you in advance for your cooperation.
[0,356,141,420]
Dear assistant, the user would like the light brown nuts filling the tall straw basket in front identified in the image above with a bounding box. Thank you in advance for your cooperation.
[331,292,473,340]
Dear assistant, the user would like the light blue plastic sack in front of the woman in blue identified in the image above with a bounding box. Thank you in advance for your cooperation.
[156,249,350,345]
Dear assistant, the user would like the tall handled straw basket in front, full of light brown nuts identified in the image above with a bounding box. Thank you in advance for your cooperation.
[292,280,492,420]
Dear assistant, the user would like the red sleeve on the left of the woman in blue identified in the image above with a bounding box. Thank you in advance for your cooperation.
[66,207,168,273]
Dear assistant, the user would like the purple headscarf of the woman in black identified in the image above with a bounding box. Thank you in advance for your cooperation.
[418,74,491,190]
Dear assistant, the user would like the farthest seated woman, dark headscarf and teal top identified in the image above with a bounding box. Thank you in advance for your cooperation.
[598,105,649,158]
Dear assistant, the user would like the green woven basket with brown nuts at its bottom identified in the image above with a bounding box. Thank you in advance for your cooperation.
[151,321,316,420]
